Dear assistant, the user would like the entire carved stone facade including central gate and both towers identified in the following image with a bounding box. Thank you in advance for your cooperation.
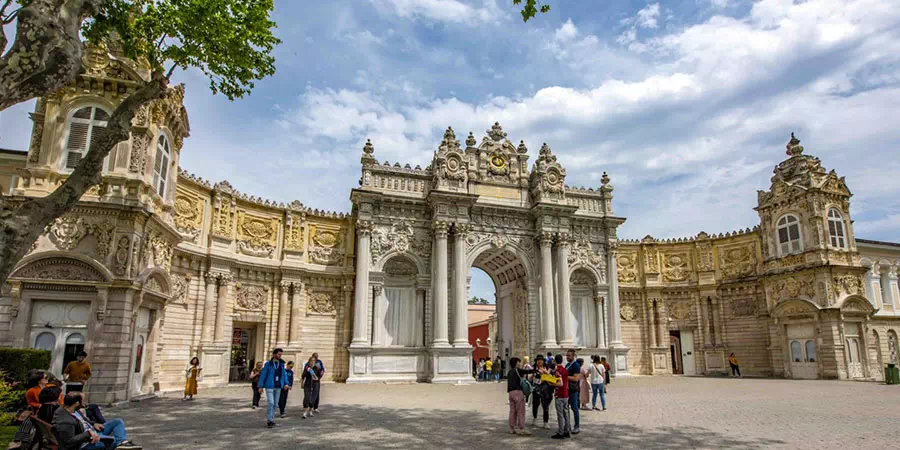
[0,47,900,402]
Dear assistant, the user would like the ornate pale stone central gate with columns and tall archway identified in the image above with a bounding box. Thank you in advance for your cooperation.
[348,123,628,382]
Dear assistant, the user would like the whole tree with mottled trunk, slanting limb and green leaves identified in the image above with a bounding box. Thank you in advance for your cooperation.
[0,0,280,285]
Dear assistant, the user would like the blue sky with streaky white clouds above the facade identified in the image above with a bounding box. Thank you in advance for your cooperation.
[0,0,900,298]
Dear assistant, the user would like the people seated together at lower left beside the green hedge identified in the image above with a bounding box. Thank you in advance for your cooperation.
[9,352,141,450]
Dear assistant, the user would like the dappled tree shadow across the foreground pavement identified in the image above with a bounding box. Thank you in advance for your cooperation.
[106,398,785,450]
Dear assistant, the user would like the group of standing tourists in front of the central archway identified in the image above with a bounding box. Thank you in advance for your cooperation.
[506,349,609,439]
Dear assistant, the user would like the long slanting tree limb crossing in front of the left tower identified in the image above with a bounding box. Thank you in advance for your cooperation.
[0,75,167,286]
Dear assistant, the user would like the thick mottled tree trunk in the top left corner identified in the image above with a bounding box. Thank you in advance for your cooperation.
[0,0,104,111]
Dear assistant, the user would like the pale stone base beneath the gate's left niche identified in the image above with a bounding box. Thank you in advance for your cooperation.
[347,346,428,384]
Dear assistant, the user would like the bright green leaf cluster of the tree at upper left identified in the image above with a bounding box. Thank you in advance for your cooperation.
[82,0,281,100]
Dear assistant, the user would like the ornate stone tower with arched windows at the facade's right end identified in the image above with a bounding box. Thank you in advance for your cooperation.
[756,134,880,379]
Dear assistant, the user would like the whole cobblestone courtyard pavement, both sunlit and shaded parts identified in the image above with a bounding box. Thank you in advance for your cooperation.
[105,377,900,450]
